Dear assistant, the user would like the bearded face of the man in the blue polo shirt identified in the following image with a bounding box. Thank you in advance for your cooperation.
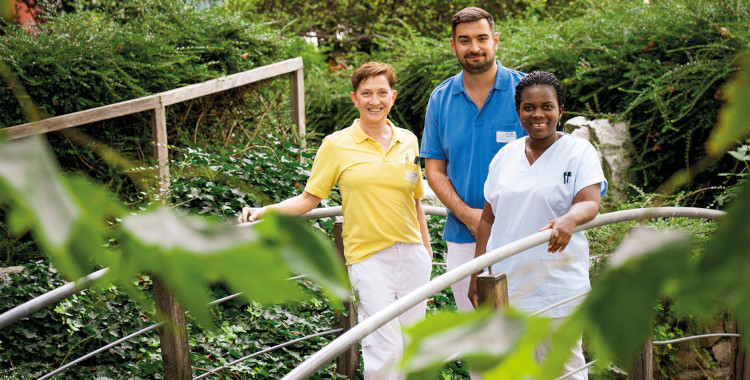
[451,19,499,74]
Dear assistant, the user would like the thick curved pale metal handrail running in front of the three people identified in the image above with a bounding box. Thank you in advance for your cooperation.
[283,207,724,380]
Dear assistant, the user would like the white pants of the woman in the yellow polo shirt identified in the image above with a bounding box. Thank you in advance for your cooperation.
[348,243,432,380]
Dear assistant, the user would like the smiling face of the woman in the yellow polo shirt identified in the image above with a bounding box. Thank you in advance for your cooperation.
[350,75,396,125]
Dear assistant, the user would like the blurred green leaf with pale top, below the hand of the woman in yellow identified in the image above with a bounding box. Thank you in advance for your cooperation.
[113,209,345,326]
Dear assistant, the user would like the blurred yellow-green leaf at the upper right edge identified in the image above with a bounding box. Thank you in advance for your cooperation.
[706,59,750,157]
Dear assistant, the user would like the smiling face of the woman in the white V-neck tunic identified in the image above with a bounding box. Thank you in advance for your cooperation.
[517,85,562,139]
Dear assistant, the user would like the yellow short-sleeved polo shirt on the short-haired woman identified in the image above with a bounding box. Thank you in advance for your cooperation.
[305,120,424,265]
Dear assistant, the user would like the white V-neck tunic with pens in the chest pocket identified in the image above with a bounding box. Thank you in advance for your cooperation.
[484,134,607,318]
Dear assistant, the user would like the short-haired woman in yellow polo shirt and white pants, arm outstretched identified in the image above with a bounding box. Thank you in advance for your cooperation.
[238,62,432,380]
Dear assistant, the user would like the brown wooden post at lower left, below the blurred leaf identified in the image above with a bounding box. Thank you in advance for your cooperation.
[154,278,193,380]
